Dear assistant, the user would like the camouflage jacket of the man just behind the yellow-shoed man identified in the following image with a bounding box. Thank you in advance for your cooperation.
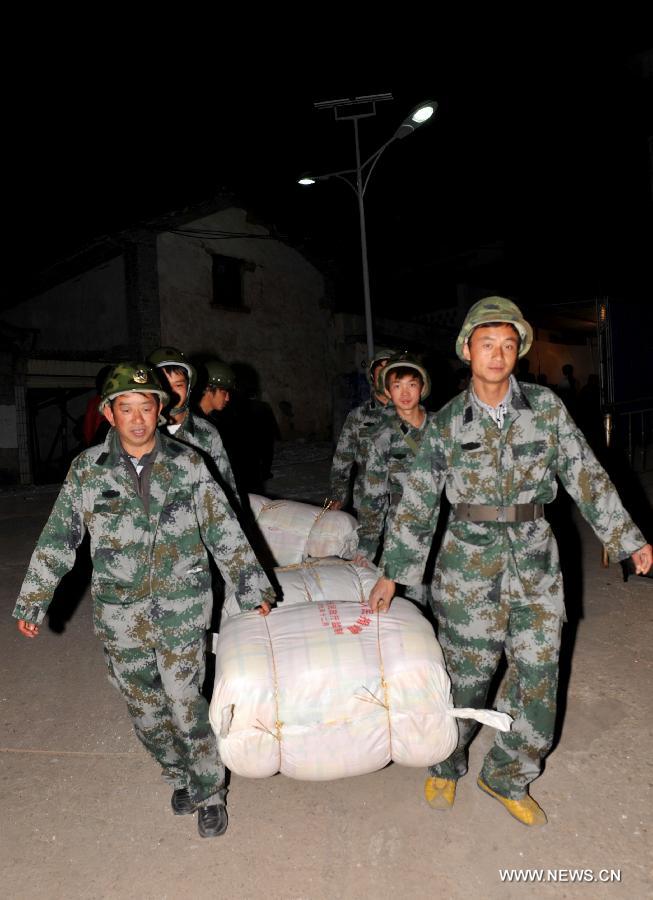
[358,403,435,560]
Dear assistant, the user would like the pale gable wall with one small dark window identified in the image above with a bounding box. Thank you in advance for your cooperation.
[158,209,333,439]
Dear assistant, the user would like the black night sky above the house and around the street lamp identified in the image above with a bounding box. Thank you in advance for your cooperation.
[3,23,653,310]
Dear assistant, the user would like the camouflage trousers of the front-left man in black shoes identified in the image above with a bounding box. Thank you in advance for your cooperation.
[104,632,226,806]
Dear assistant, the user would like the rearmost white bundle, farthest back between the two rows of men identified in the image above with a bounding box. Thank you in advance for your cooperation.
[249,494,358,566]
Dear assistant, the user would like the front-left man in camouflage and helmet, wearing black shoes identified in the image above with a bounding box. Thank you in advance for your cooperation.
[13,363,271,837]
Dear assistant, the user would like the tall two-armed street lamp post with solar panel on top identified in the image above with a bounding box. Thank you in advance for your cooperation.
[298,94,438,360]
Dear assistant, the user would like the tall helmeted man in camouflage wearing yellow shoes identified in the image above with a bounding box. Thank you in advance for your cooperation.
[370,297,653,825]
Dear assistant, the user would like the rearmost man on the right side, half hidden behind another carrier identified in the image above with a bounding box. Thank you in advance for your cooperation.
[331,347,395,509]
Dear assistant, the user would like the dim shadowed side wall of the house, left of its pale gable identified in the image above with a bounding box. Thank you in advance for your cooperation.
[2,257,129,358]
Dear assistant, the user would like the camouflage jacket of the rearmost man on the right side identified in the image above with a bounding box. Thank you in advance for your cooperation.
[331,397,385,508]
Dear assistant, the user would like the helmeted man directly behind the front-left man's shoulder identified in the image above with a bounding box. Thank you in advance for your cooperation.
[147,347,238,509]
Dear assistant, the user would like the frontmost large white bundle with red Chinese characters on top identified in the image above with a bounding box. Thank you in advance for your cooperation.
[209,598,510,781]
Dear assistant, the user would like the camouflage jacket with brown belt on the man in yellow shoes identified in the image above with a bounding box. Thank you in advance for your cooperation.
[381,378,646,613]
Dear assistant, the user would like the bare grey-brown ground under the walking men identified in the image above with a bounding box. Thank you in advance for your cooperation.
[0,448,653,900]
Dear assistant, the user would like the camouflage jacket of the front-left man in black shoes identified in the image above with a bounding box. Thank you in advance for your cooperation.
[13,428,271,636]
